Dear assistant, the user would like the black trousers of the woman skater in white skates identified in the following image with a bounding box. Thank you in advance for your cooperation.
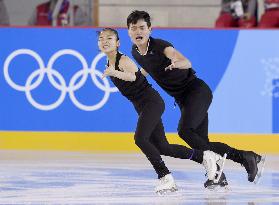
[133,87,197,178]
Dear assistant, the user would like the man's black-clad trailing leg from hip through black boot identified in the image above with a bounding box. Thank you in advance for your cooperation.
[178,79,261,181]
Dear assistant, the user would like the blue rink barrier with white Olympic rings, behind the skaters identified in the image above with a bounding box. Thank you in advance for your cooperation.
[0,28,279,134]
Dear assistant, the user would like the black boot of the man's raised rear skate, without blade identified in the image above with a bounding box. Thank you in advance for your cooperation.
[242,151,261,182]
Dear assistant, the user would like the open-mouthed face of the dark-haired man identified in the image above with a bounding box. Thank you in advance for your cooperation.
[128,19,151,46]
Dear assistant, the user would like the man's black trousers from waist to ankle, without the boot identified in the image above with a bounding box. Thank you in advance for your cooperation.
[176,78,244,163]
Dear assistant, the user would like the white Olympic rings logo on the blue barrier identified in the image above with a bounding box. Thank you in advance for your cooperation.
[4,49,118,111]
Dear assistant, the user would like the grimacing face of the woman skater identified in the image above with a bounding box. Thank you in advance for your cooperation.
[98,30,120,54]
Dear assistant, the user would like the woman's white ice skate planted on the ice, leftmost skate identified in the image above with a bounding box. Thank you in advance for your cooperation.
[155,174,178,195]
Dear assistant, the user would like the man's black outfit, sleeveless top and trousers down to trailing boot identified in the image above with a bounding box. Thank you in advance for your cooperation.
[132,37,260,181]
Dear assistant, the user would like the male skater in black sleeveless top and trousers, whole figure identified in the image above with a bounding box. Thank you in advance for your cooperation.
[127,10,264,187]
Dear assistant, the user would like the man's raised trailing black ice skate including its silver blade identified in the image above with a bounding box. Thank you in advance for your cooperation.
[242,151,265,184]
